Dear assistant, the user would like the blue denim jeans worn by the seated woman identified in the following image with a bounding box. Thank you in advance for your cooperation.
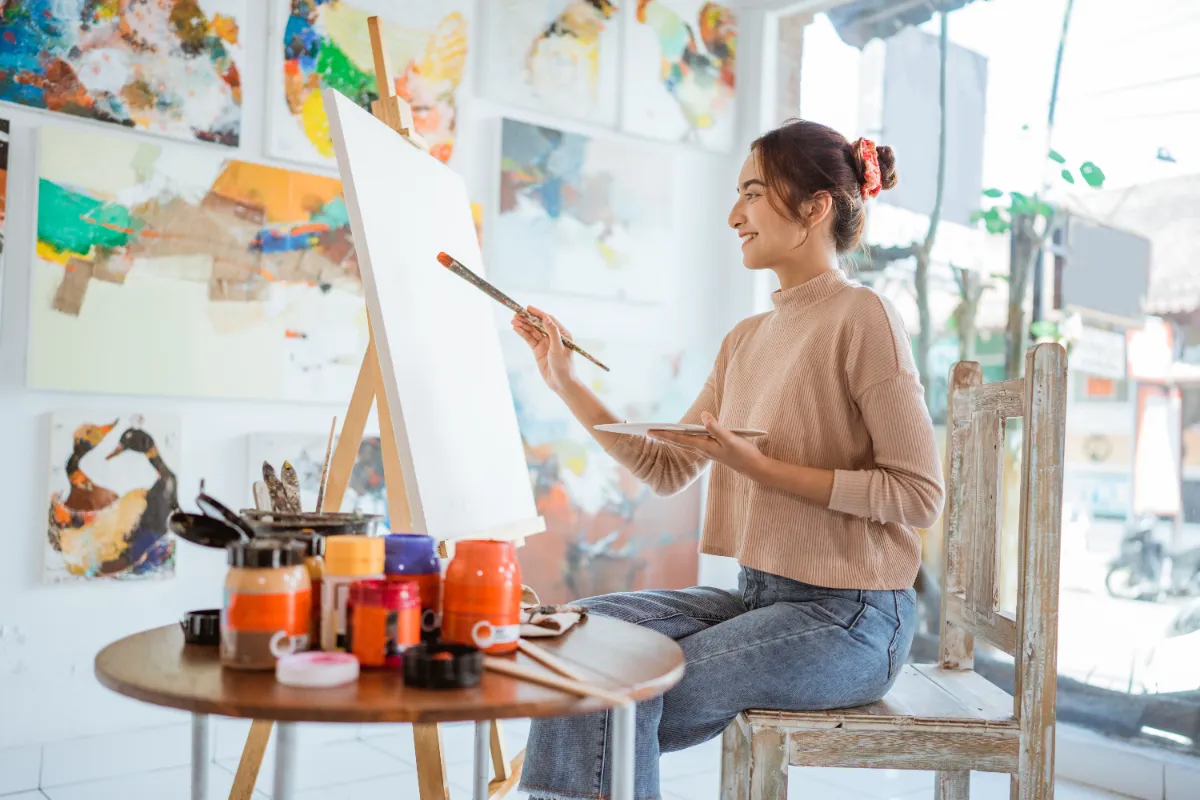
[521,567,917,800]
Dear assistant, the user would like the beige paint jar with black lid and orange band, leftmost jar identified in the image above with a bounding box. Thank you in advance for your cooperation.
[221,540,312,669]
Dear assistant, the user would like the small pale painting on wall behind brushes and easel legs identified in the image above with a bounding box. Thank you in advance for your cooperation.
[247,433,388,530]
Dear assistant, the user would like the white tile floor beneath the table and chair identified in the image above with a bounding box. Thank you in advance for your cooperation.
[0,720,1126,800]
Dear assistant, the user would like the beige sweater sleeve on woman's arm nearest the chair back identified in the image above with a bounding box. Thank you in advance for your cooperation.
[829,293,944,528]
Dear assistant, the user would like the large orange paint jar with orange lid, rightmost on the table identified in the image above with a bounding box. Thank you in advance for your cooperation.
[442,540,521,654]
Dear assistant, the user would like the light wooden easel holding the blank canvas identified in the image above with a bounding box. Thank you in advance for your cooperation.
[229,17,524,800]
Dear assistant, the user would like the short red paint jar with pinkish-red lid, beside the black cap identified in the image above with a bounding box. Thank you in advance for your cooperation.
[346,581,421,667]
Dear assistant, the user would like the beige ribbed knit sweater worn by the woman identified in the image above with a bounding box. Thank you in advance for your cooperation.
[608,270,943,589]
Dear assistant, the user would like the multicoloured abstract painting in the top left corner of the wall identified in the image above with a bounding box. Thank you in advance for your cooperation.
[0,0,246,146]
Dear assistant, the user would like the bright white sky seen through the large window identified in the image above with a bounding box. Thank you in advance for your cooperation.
[800,0,1200,191]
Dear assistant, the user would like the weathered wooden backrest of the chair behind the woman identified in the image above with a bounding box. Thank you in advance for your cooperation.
[938,344,1067,727]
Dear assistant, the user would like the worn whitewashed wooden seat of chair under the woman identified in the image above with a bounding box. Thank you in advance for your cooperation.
[738,664,1020,772]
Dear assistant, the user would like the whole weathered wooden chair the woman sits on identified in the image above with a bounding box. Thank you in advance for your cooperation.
[721,344,1067,800]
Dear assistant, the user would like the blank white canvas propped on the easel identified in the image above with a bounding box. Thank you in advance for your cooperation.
[324,90,544,539]
